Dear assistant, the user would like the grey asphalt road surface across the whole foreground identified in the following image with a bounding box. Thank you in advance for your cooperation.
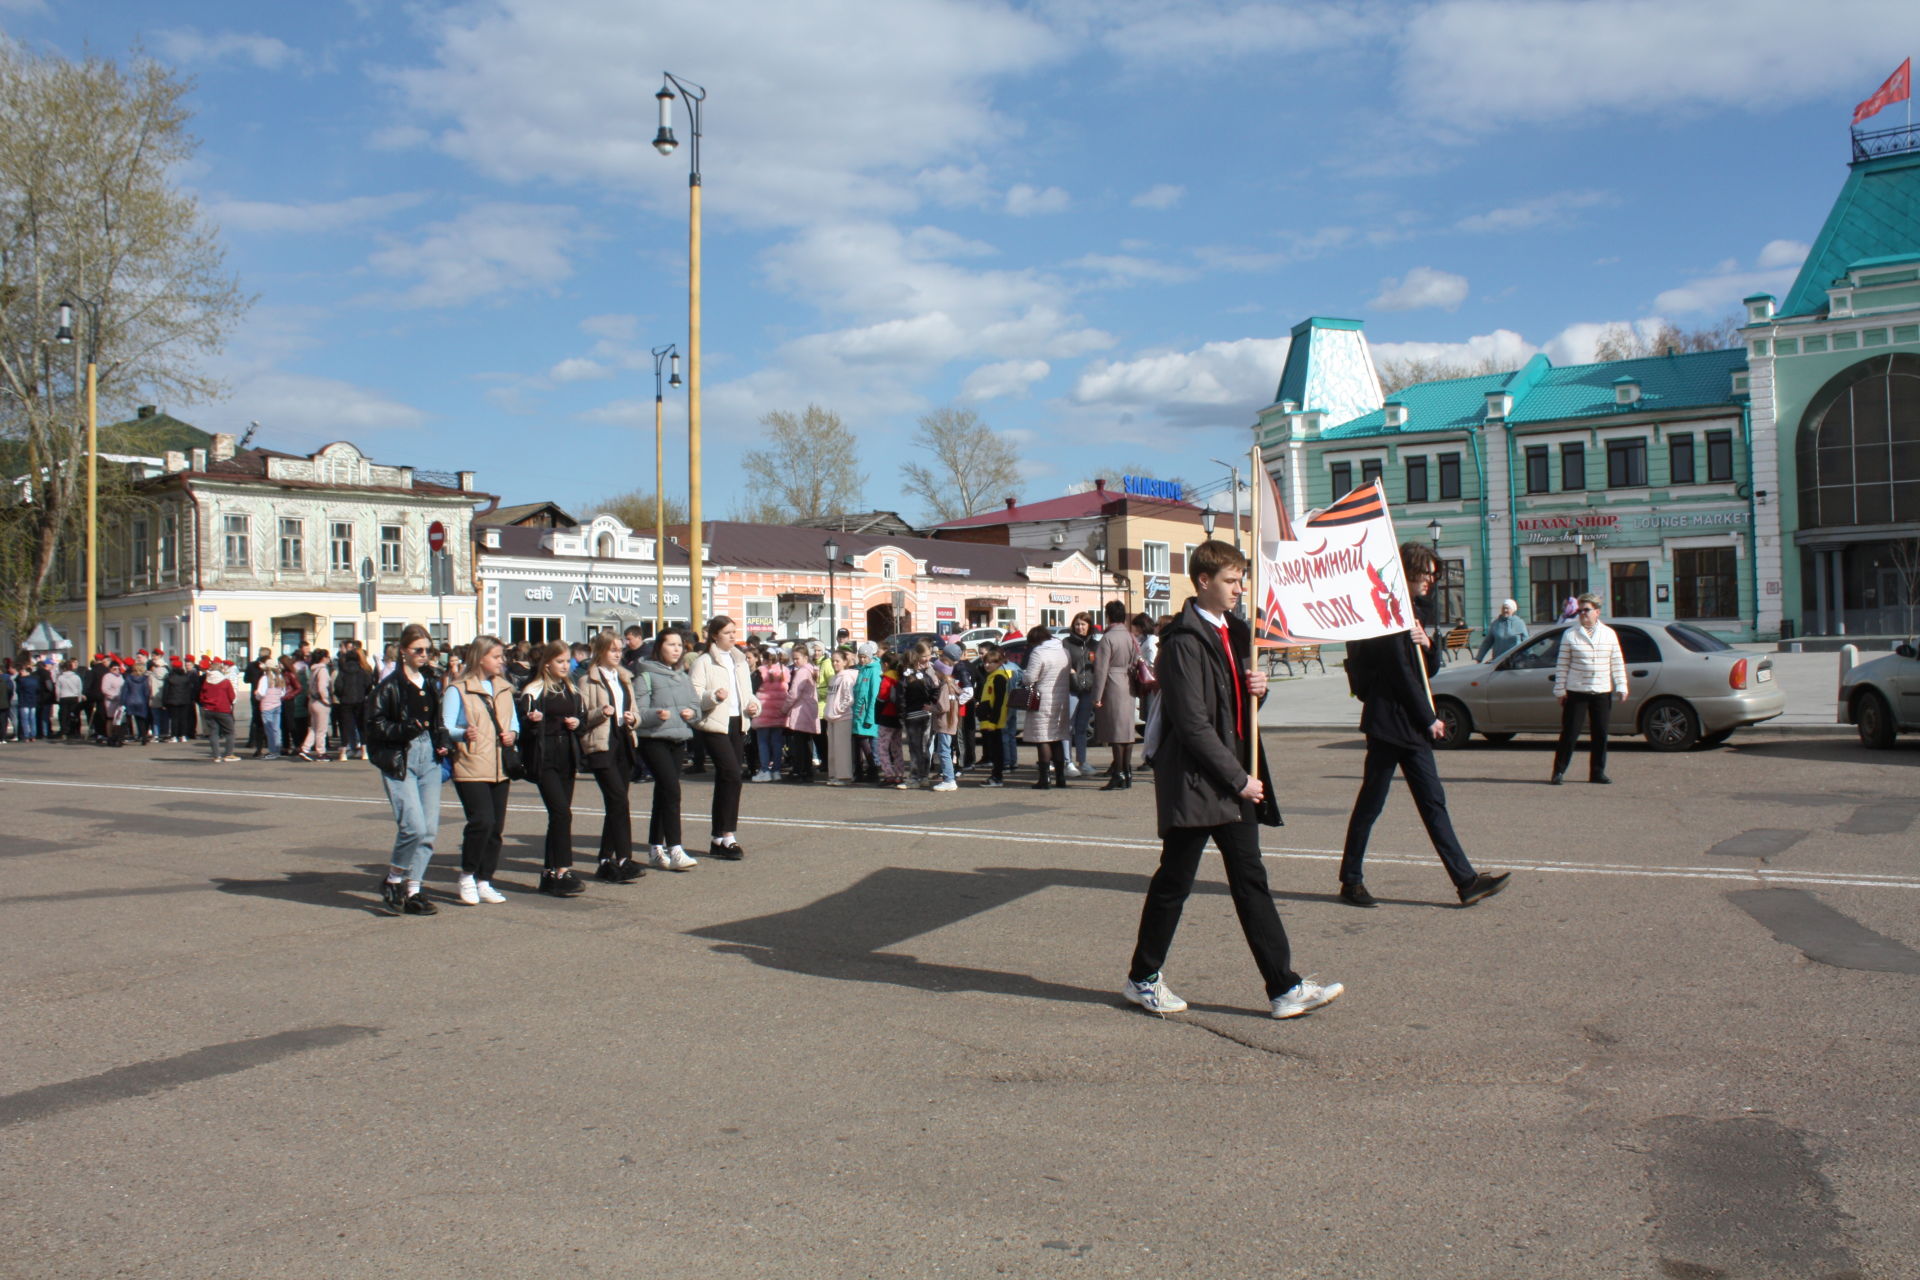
[0,731,1920,1280]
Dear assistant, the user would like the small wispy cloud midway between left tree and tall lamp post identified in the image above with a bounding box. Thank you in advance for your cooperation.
[369,203,580,307]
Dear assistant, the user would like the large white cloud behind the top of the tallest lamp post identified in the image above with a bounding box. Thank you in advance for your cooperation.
[392,0,1068,225]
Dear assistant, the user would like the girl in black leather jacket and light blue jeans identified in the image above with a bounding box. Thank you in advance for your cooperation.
[364,622,451,915]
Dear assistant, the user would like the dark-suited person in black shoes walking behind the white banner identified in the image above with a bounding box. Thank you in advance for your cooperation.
[1340,541,1509,906]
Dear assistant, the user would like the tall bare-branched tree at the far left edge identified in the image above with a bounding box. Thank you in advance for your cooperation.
[0,42,252,643]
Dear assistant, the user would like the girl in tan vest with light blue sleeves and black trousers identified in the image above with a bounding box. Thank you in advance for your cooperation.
[441,635,520,906]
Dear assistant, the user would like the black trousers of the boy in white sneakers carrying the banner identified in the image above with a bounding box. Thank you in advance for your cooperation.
[1127,821,1300,1000]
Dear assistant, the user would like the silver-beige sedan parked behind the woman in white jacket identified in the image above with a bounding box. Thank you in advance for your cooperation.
[1432,618,1788,750]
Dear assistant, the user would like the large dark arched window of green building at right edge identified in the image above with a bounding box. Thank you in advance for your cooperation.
[1795,355,1920,530]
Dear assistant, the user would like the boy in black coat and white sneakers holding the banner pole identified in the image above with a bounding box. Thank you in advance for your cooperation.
[1121,539,1346,1017]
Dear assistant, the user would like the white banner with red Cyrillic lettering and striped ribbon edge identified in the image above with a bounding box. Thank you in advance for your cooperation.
[1254,462,1419,645]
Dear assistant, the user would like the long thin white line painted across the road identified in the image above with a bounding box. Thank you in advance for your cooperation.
[11,777,1920,889]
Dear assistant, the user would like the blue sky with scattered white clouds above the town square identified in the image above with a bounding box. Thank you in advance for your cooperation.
[0,0,1920,518]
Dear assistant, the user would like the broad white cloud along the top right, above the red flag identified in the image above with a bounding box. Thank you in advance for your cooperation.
[1394,0,1920,130]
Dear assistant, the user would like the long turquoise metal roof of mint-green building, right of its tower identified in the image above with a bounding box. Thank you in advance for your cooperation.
[1321,349,1747,439]
